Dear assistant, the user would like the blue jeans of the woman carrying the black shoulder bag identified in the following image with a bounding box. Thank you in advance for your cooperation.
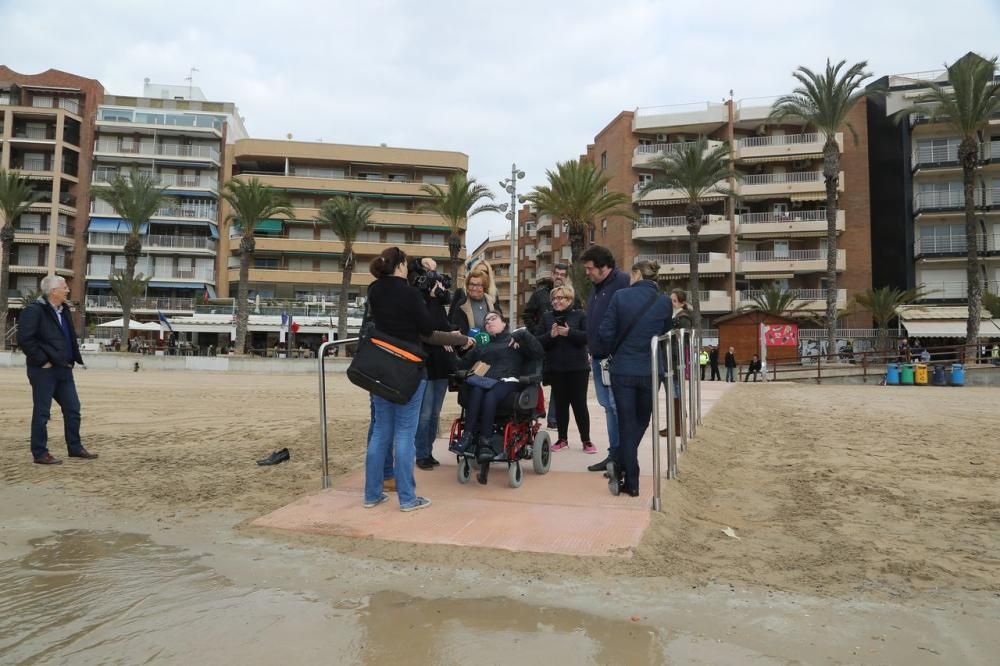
[365,380,427,508]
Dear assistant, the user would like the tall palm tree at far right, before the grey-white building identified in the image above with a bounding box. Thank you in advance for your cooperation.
[897,53,1000,346]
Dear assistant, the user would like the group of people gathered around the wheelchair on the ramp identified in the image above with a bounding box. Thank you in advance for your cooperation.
[364,245,693,511]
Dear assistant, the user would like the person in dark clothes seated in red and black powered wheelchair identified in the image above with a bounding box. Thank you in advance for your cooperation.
[448,312,548,485]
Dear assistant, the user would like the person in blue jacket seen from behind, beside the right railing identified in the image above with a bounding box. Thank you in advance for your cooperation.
[598,261,673,497]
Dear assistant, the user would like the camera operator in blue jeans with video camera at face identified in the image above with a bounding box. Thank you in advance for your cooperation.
[410,257,457,470]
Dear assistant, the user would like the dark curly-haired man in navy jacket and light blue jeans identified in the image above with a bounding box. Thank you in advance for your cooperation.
[580,245,629,472]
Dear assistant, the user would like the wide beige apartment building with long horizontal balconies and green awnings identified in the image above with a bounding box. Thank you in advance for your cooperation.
[218,139,469,302]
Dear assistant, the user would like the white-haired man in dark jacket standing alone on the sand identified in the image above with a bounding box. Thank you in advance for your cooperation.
[17,275,97,465]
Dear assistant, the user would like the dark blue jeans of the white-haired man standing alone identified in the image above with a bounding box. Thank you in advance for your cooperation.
[28,365,83,459]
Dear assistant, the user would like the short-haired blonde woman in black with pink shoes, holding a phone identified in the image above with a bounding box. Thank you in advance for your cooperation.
[538,286,597,453]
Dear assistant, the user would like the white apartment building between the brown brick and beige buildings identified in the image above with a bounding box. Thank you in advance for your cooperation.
[86,84,247,319]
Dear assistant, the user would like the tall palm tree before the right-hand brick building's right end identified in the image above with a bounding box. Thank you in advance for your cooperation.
[770,59,874,358]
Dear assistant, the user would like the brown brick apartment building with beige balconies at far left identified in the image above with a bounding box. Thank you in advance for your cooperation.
[0,65,104,330]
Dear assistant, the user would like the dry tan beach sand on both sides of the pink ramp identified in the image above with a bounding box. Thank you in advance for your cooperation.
[0,370,1000,598]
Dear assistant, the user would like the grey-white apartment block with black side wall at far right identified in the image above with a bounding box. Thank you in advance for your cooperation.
[869,54,1000,304]
